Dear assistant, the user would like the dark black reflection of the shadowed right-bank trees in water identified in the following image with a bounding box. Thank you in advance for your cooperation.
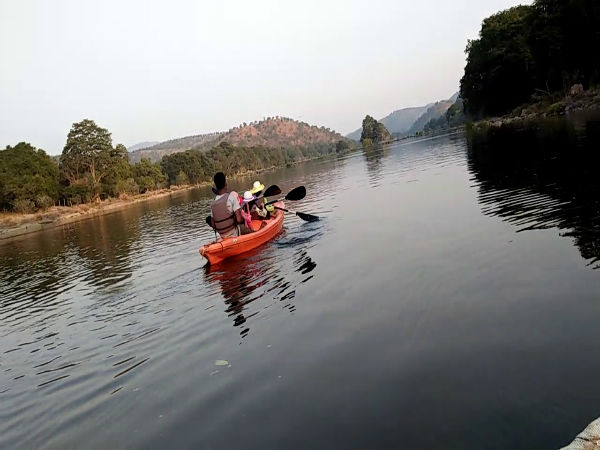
[468,117,600,268]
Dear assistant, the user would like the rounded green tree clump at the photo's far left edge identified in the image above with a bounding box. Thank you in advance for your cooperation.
[0,142,59,212]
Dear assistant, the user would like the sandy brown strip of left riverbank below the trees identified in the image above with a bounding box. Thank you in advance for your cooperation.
[0,183,202,240]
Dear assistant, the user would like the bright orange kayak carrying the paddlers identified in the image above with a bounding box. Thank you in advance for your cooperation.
[200,202,285,264]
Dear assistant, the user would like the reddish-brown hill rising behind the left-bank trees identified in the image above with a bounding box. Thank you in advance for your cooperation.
[129,117,344,162]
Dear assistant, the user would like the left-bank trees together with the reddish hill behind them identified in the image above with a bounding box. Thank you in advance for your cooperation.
[0,118,351,213]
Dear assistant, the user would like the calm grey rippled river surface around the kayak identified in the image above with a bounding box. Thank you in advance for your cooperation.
[0,117,600,449]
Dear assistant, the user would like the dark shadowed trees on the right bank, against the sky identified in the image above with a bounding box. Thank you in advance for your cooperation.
[460,0,600,119]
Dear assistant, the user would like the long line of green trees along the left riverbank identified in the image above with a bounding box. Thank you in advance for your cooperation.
[0,119,348,213]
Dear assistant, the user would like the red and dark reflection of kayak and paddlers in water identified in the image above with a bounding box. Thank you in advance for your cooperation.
[205,250,317,337]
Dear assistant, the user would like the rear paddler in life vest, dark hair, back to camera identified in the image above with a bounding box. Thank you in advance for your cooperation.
[210,172,252,239]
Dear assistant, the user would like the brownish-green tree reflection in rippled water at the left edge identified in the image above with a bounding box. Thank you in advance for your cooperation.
[0,210,139,326]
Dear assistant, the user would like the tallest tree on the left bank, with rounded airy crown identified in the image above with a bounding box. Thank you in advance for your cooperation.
[60,119,114,199]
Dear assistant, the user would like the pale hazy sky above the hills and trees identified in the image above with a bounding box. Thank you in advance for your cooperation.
[0,0,531,154]
